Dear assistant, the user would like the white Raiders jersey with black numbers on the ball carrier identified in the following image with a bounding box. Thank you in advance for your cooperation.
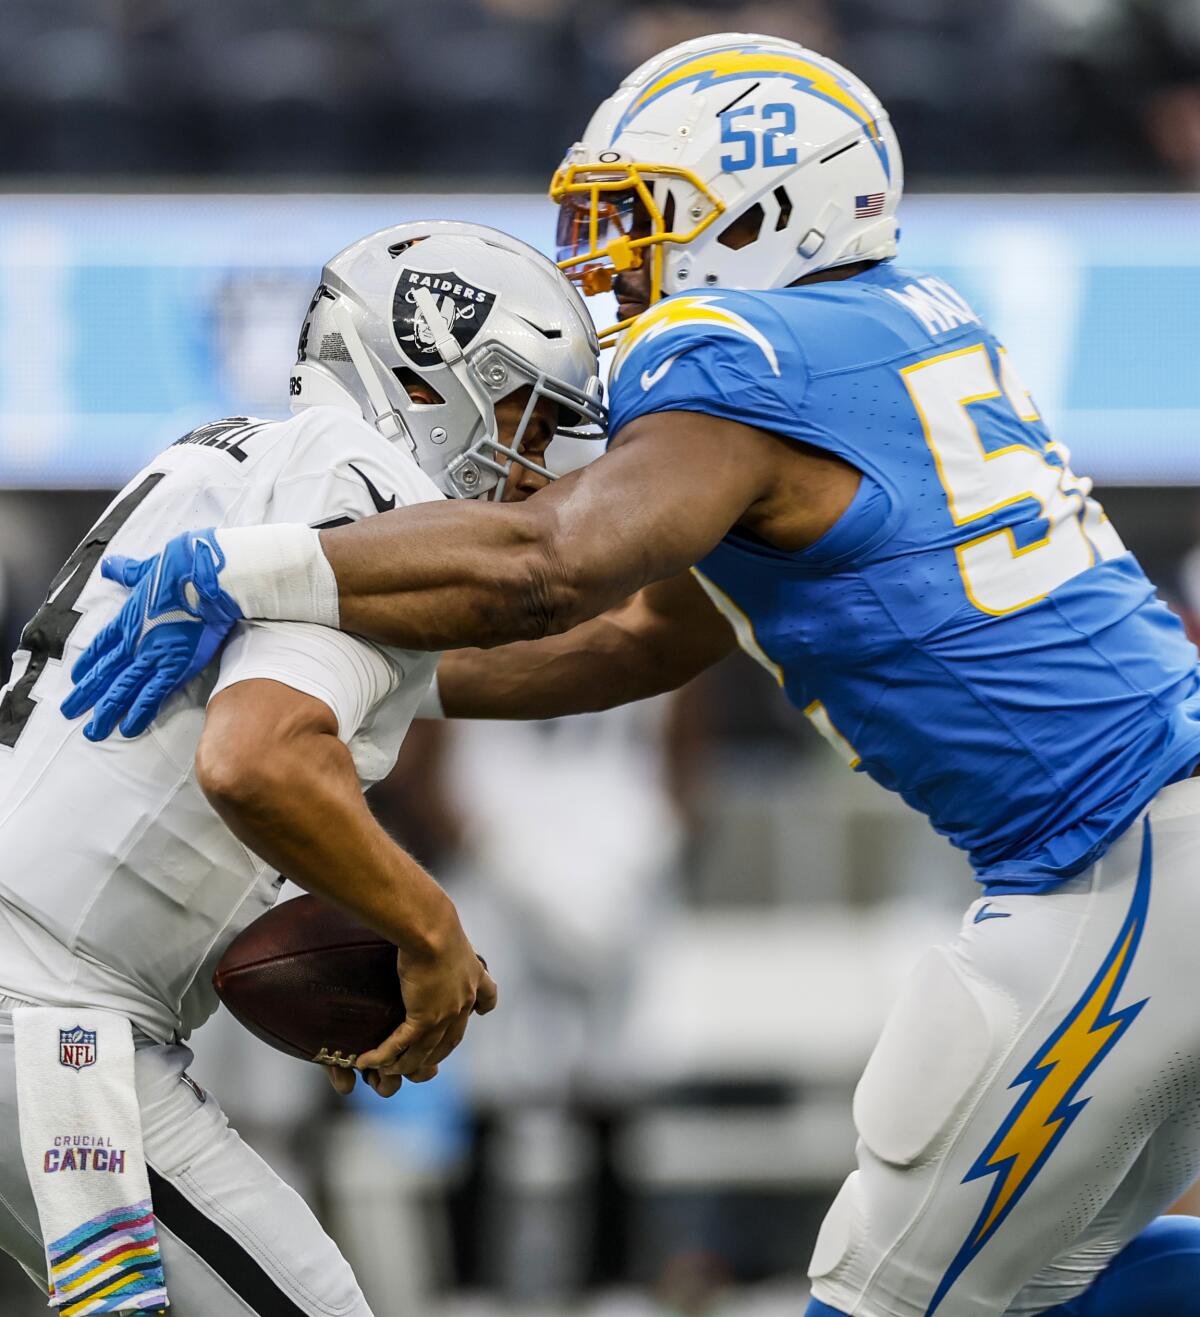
[0,407,443,1040]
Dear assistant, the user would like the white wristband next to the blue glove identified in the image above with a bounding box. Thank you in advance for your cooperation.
[216,525,339,627]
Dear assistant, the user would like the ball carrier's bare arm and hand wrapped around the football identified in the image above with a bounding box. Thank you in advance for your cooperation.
[196,680,495,1090]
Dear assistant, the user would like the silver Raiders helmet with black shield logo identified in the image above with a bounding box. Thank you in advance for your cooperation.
[290,220,606,498]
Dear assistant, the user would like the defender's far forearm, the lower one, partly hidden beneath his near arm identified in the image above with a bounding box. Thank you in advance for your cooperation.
[426,572,736,718]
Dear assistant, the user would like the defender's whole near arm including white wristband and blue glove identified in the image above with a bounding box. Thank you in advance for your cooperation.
[62,411,859,740]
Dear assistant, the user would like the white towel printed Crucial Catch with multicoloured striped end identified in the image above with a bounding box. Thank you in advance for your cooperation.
[13,1006,167,1317]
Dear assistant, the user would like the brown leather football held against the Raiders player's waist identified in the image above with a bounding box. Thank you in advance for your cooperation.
[212,896,404,1065]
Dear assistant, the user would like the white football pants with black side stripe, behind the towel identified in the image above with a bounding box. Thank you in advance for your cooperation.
[0,997,371,1317]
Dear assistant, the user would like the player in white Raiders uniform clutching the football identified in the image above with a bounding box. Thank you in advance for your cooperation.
[0,223,603,1317]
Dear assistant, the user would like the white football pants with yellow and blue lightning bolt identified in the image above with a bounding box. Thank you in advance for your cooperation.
[810,778,1200,1317]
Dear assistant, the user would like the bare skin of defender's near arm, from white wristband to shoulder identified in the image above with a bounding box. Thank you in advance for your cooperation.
[314,412,781,649]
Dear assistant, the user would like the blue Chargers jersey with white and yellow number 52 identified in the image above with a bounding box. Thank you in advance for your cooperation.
[611,262,1200,892]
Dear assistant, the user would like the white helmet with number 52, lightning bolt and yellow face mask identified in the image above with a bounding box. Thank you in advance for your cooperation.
[551,32,904,341]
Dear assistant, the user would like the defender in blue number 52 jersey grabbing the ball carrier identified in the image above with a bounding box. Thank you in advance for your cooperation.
[60,34,1200,1317]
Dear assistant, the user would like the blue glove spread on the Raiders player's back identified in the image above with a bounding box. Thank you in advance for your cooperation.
[62,528,242,741]
